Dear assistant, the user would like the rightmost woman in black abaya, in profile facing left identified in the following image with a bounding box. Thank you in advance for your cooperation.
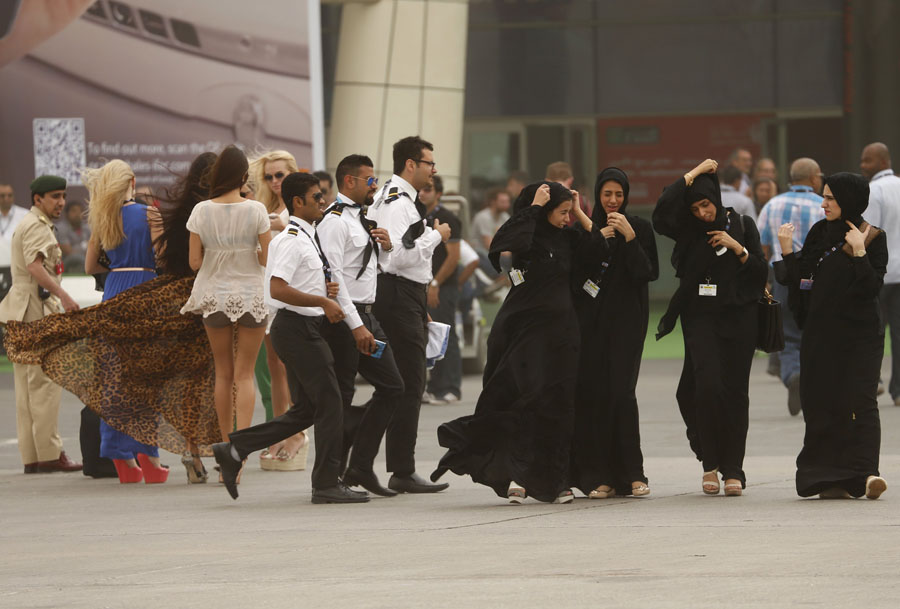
[775,173,888,499]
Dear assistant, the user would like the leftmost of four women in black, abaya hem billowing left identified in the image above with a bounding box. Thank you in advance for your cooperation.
[431,182,603,503]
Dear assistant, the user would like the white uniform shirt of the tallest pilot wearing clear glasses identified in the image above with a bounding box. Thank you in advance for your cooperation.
[367,175,441,284]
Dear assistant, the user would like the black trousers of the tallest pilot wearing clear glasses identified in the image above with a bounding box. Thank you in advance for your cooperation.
[374,274,428,476]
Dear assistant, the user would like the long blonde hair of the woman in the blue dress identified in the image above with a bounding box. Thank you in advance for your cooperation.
[81,159,134,250]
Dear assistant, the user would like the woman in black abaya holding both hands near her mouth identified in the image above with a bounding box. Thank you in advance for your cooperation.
[572,167,659,499]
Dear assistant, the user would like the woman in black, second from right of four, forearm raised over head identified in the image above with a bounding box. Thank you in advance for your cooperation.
[653,159,768,496]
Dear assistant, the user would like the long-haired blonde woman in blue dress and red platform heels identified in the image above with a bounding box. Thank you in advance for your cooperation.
[82,159,169,484]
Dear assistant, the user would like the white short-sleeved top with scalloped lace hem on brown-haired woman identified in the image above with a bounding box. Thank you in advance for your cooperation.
[181,200,269,322]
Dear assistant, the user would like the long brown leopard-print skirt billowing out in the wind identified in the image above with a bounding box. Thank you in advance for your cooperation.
[5,275,221,456]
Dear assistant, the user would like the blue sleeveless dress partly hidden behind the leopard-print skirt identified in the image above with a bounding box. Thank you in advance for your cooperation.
[100,203,159,459]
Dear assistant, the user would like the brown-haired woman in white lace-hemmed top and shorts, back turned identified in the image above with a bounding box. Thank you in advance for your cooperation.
[181,146,272,456]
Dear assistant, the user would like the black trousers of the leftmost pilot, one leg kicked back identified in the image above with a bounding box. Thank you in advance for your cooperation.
[229,309,343,489]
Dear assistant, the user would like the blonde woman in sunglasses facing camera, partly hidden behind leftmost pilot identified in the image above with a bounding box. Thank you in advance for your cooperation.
[250,150,309,471]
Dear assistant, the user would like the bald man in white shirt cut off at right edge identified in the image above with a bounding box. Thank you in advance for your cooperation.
[859,142,900,406]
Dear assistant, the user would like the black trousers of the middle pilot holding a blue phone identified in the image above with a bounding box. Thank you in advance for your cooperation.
[323,309,403,471]
